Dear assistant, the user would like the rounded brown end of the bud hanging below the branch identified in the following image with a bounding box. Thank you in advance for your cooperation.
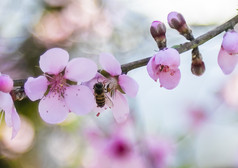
[191,57,205,76]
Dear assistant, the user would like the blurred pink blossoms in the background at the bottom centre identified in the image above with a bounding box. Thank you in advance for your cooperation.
[83,121,176,168]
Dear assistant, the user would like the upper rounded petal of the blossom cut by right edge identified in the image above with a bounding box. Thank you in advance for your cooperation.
[222,30,238,54]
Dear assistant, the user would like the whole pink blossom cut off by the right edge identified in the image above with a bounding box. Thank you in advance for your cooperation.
[218,30,238,74]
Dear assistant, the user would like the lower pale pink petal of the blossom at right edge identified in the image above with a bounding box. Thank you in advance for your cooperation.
[218,47,238,74]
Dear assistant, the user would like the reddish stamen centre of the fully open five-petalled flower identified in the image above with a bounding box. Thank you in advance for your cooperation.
[48,73,68,97]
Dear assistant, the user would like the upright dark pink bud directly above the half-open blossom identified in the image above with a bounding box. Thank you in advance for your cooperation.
[150,21,166,49]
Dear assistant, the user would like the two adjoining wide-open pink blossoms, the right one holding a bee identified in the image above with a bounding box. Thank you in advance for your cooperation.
[24,48,138,124]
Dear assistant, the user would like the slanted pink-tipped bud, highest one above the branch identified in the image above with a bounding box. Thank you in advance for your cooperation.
[167,12,194,40]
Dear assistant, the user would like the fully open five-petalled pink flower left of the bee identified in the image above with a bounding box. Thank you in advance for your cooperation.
[24,48,97,124]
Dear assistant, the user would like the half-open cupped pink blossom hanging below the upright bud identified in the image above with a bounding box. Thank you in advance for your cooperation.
[147,48,181,89]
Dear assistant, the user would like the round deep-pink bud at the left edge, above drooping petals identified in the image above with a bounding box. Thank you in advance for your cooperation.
[0,75,13,93]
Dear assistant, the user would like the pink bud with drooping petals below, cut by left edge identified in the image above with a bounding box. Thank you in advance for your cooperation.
[0,73,21,139]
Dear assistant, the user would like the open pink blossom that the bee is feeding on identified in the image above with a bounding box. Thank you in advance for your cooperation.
[87,53,138,123]
